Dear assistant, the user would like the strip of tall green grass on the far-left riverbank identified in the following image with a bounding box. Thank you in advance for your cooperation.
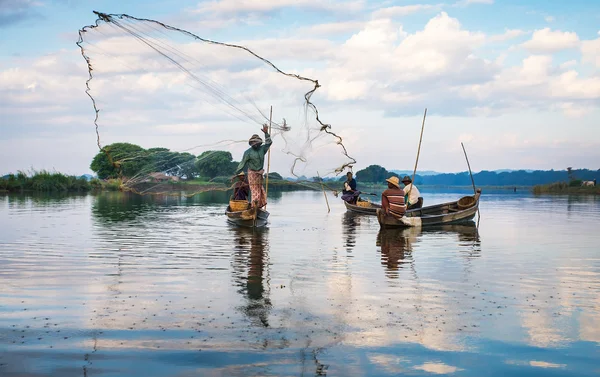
[0,170,94,192]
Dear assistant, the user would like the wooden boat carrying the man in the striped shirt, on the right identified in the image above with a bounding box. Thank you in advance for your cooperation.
[377,189,481,228]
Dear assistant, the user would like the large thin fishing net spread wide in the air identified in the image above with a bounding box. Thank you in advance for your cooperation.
[77,12,355,193]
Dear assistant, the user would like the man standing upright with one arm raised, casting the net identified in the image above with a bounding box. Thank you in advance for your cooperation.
[235,124,273,208]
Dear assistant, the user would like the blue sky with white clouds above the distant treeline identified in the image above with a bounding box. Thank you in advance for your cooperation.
[0,0,600,175]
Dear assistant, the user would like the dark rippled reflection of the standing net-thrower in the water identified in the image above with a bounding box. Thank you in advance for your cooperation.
[233,227,272,327]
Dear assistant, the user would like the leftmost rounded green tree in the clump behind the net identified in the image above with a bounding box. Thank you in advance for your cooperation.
[90,143,148,179]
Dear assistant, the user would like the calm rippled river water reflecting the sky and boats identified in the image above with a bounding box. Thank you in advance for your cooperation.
[0,190,600,377]
